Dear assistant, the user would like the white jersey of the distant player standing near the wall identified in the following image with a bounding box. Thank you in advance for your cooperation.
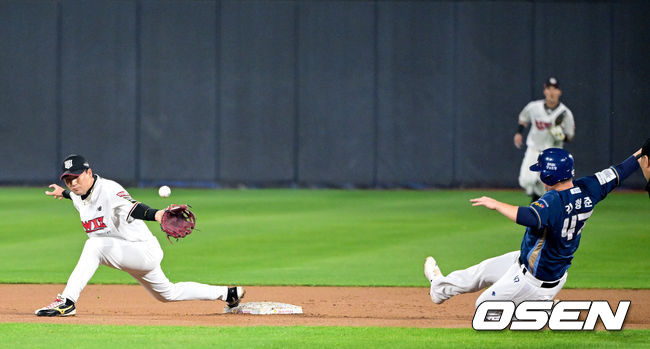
[519,99,575,152]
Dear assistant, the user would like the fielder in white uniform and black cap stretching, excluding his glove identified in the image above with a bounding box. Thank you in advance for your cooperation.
[36,155,245,316]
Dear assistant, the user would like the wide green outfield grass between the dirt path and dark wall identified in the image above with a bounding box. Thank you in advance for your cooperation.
[0,188,650,288]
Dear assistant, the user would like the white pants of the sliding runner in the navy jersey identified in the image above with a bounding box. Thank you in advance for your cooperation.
[429,251,567,307]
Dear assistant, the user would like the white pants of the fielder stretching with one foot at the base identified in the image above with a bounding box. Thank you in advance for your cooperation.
[61,237,228,302]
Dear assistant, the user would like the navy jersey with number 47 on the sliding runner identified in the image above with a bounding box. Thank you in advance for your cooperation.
[519,167,621,281]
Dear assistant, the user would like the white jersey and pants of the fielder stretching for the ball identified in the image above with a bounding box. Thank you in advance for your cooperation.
[61,175,228,302]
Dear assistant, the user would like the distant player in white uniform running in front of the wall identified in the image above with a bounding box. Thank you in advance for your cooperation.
[514,77,575,202]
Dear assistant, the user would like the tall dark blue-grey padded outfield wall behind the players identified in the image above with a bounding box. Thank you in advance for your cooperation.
[0,0,650,187]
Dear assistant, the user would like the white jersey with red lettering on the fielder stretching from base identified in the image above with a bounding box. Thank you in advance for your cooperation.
[70,176,154,241]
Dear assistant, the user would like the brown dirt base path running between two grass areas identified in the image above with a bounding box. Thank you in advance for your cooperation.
[0,284,650,329]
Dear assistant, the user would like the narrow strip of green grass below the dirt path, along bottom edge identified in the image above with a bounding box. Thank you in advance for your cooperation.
[0,323,650,348]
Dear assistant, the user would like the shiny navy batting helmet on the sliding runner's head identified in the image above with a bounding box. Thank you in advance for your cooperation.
[530,148,575,185]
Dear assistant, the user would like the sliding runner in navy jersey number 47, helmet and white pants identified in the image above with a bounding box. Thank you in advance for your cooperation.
[424,143,642,307]
